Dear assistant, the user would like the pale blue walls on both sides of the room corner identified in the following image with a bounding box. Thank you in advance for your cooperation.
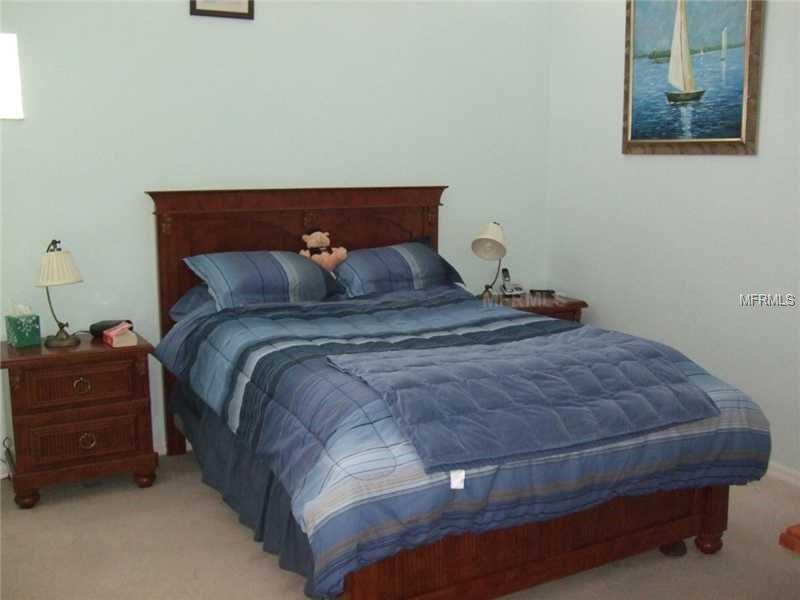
[0,0,800,478]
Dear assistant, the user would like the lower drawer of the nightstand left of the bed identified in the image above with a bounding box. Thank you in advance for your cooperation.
[28,413,138,468]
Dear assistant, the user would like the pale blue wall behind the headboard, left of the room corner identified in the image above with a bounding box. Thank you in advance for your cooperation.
[0,0,549,452]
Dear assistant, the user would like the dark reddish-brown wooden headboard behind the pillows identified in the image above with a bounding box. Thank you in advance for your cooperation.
[147,186,446,453]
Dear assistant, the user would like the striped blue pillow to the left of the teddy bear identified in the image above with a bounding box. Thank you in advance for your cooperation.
[183,250,339,310]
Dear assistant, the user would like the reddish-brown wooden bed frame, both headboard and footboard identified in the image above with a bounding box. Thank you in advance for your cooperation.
[149,187,728,600]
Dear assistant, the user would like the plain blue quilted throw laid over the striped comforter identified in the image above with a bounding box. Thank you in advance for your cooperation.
[328,332,719,472]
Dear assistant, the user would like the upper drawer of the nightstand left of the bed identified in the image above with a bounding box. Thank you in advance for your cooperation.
[25,360,135,409]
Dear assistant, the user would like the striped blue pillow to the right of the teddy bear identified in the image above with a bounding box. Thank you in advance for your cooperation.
[335,242,463,298]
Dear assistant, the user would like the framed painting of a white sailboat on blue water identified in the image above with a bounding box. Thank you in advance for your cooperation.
[622,0,764,154]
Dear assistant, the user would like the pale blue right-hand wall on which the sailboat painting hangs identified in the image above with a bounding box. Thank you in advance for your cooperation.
[548,1,800,471]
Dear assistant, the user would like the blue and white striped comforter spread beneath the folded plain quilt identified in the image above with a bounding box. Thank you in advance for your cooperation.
[156,286,770,596]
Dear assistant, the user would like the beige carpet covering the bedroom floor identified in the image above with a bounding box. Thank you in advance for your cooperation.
[0,455,800,600]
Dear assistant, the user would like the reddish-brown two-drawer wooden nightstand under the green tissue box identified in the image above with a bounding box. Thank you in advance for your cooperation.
[0,335,158,508]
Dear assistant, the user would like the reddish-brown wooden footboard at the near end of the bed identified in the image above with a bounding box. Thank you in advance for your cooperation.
[344,486,728,600]
